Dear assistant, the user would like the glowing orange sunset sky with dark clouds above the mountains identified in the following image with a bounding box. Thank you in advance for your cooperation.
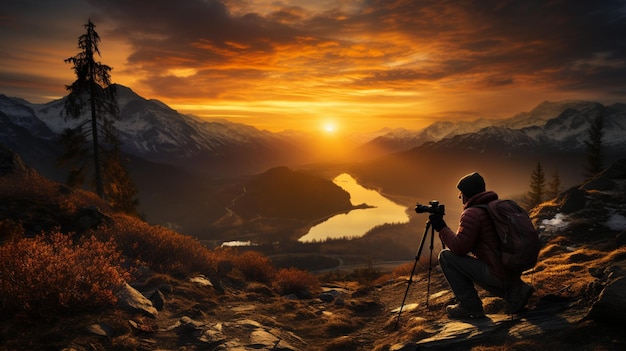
[0,0,626,133]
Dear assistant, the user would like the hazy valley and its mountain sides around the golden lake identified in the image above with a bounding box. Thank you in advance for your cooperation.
[0,90,626,276]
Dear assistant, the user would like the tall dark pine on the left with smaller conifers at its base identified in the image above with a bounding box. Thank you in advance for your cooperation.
[58,20,138,214]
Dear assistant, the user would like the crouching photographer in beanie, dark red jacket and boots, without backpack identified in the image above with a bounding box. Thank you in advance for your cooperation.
[429,173,533,318]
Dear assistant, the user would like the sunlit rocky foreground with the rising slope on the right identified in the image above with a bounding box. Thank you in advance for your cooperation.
[0,155,626,351]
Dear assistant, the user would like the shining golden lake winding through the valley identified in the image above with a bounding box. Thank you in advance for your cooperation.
[298,173,409,242]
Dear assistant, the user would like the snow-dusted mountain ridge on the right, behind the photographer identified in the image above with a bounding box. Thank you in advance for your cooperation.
[360,101,626,156]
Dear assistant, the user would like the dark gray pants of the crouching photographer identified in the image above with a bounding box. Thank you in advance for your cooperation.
[439,249,509,313]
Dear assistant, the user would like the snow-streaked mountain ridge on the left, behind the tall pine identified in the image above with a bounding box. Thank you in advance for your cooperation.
[6,85,312,174]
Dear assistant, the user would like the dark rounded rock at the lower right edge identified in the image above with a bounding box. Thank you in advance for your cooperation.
[589,276,626,325]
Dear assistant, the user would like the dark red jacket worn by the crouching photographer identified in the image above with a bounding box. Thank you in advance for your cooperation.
[439,191,507,278]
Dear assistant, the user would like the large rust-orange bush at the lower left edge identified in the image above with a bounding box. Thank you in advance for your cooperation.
[0,232,130,315]
